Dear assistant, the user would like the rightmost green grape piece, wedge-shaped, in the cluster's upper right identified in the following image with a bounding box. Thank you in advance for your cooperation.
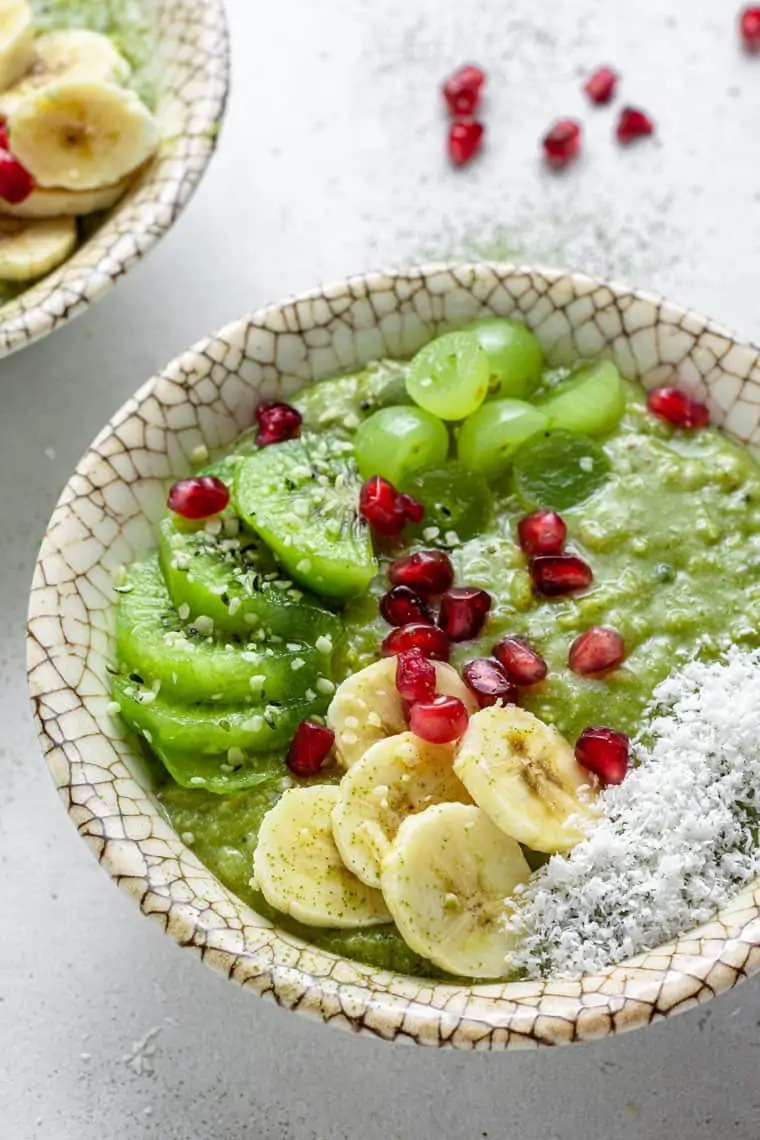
[538,360,626,435]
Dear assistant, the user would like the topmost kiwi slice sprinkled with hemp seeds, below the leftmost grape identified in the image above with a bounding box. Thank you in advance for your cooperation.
[232,435,377,599]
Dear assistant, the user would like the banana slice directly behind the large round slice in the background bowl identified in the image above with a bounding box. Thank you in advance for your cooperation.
[0,27,131,119]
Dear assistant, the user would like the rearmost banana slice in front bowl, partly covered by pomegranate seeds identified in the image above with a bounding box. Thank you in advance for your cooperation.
[327,657,477,768]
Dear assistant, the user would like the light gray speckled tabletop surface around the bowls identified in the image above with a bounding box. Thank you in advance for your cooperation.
[0,0,760,1140]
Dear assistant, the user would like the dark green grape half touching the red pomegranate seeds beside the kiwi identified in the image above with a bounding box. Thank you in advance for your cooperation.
[401,462,493,546]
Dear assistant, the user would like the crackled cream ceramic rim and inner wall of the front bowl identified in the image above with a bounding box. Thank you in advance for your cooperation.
[28,264,760,1049]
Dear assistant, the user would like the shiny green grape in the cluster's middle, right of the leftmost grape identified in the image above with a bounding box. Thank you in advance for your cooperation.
[457,400,548,479]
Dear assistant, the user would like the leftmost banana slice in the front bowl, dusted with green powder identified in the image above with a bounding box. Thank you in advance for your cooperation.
[251,784,391,930]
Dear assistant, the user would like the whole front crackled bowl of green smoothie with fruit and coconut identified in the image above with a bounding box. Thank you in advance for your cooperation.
[28,263,760,1049]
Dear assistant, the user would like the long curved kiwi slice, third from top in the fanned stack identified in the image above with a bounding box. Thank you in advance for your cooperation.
[116,556,330,703]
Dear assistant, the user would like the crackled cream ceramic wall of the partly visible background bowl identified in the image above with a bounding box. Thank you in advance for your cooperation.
[0,0,229,357]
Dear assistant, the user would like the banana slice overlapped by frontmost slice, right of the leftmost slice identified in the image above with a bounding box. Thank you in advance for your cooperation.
[333,732,471,887]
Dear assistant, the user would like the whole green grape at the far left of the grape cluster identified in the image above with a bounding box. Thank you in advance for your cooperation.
[354,406,449,487]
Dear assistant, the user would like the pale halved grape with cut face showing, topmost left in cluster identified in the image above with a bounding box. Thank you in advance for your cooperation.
[407,333,489,420]
